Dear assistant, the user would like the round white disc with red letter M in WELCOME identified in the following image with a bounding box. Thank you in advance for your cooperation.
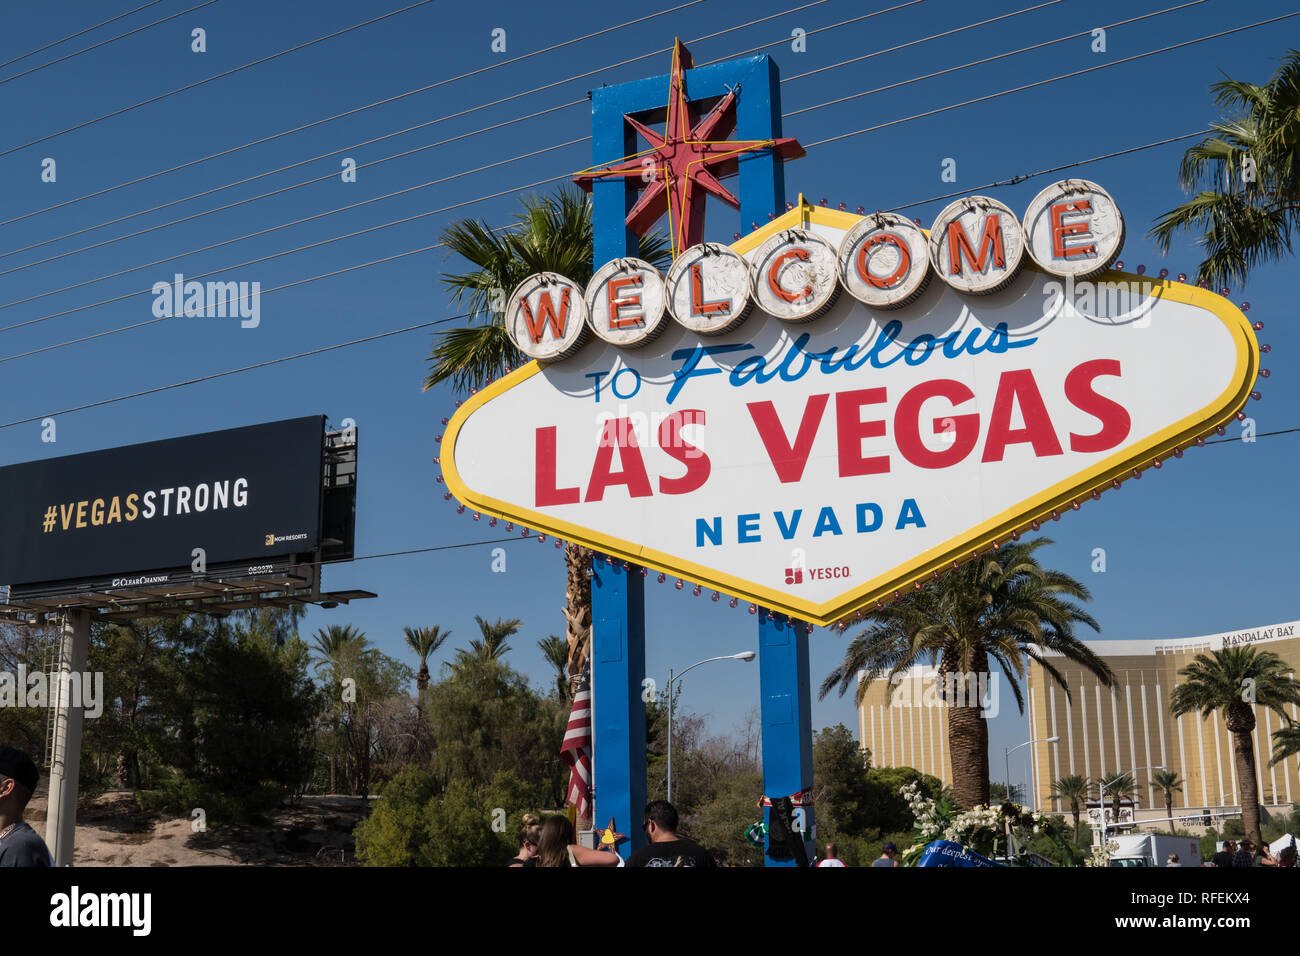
[930,196,1024,295]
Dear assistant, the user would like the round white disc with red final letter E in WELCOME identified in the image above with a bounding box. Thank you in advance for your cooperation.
[1024,179,1125,278]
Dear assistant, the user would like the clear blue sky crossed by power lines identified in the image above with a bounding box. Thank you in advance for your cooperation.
[0,0,1300,806]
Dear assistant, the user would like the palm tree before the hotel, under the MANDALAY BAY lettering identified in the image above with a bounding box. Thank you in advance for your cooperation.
[1169,645,1300,845]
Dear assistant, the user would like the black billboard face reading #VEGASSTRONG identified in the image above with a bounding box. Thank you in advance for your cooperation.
[0,415,325,585]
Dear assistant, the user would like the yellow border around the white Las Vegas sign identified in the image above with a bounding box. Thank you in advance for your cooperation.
[441,195,1260,624]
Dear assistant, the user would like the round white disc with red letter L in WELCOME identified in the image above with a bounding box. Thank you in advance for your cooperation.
[664,242,754,336]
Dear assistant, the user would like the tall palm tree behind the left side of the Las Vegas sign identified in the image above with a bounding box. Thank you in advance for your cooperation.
[424,187,671,687]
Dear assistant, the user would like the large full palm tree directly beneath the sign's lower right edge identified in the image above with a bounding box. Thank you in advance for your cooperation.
[820,538,1113,809]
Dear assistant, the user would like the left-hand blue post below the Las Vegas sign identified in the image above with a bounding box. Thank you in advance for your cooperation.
[592,555,646,856]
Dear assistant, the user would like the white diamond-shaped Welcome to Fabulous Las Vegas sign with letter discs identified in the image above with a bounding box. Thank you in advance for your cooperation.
[442,181,1258,624]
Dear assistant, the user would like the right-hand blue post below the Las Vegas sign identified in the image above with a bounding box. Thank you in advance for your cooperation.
[758,607,814,866]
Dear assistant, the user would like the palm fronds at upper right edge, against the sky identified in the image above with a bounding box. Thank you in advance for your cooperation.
[1151,49,1300,287]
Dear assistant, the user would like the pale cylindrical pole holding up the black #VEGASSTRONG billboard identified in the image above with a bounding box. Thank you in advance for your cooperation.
[46,609,90,866]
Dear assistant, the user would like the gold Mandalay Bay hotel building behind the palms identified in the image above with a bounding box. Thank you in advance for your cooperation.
[858,622,1300,827]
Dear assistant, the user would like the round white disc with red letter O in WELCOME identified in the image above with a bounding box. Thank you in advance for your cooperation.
[840,212,931,308]
